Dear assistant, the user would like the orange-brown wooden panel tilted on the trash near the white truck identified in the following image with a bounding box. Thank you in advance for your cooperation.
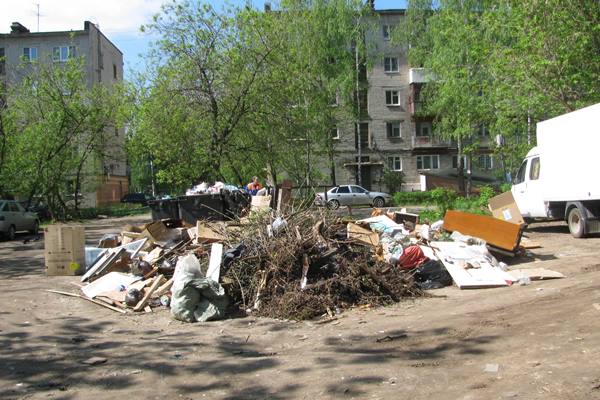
[444,210,523,251]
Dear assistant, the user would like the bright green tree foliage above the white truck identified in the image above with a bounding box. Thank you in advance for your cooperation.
[395,0,600,181]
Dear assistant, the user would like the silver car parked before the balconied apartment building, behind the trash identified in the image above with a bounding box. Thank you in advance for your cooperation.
[315,185,392,210]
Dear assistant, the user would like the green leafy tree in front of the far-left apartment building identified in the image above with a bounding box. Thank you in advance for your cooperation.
[0,59,123,219]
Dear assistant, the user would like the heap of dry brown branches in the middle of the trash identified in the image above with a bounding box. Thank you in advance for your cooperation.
[222,210,423,320]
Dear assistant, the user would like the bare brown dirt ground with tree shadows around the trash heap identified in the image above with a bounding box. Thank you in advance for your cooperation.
[0,217,600,400]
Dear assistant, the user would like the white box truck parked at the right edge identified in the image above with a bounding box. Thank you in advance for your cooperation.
[511,103,600,238]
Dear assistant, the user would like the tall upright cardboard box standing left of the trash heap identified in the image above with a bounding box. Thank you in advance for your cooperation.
[44,224,85,276]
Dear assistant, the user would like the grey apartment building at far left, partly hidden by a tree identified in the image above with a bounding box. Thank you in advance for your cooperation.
[0,21,129,207]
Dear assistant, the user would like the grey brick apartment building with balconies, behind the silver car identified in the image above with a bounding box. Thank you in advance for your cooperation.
[334,9,494,191]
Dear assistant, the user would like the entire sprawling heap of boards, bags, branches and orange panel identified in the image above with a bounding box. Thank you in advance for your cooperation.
[46,192,562,320]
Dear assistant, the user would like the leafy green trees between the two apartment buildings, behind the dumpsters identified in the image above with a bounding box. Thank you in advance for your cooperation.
[129,0,366,187]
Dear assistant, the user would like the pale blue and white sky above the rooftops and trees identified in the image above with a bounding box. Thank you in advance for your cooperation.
[0,0,406,79]
